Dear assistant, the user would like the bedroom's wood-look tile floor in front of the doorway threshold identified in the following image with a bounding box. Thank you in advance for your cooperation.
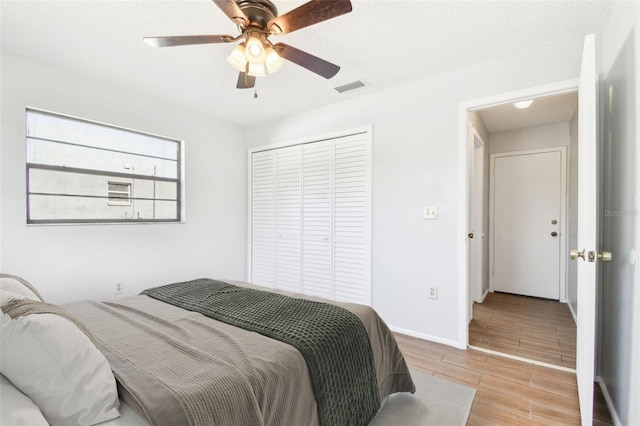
[394,333,612,425]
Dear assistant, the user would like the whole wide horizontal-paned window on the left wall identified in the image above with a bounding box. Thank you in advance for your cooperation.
[26,109,182,224]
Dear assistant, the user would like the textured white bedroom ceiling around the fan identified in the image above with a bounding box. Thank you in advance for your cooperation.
[0,0,611,125]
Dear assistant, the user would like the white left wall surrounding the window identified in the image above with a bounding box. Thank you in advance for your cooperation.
[0,51,247,303]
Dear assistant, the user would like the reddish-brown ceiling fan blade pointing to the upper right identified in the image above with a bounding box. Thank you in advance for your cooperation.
[267,0,352,34]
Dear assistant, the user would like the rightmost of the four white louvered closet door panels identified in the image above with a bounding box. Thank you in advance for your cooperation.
[333,135,371,304]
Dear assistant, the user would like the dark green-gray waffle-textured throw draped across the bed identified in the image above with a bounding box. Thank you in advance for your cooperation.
[142,279,380,426]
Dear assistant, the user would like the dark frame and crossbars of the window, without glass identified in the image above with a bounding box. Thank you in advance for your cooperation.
[24,107,185,225]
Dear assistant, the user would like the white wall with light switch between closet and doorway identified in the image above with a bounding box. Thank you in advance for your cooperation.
[247,40,582,344]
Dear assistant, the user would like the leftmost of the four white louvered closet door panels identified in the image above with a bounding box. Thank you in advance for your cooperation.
[251,151,276,287]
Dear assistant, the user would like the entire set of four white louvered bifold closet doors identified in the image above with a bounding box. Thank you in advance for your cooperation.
[250,132,371,304]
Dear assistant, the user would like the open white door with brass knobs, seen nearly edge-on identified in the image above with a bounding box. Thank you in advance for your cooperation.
[572,34,597,425]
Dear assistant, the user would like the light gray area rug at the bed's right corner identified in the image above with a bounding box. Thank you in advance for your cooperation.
[370,370,476,426]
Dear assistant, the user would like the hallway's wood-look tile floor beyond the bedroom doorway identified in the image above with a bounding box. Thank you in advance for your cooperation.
[469,293,576,369]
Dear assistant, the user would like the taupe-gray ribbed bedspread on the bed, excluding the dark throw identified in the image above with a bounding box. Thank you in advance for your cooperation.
[65,282,415,426]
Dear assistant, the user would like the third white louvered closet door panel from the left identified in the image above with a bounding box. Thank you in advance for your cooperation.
[302,141,333,299]
